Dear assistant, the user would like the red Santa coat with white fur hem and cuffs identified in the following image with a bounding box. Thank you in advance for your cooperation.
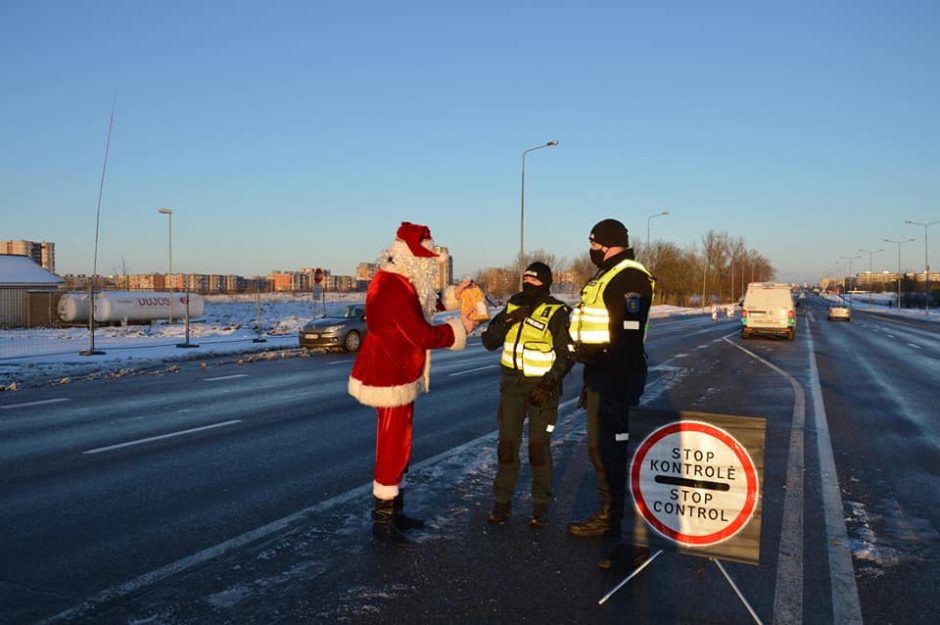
[349,269,467,408]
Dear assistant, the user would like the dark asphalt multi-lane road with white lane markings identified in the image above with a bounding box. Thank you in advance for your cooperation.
[0,308,940,625]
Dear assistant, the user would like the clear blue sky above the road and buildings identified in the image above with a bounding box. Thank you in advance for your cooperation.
[0,0,940,281]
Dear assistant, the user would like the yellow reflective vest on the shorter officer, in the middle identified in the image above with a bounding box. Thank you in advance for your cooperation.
[499,302,565,378]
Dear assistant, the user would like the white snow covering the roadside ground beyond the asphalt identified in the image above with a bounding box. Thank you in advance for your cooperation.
[0,293,940,391]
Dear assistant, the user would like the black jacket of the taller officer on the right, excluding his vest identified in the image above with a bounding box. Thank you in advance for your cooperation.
[584,249,653,404]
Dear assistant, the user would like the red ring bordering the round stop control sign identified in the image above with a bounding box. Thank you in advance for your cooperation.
[630,421,757,546]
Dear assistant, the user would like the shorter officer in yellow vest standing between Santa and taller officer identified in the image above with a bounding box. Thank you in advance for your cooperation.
[482,262,573,527]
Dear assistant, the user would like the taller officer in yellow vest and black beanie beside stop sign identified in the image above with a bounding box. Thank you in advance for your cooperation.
[568,219,655,537]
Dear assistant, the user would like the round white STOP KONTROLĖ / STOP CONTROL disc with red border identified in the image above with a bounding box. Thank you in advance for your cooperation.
[630,420,759,547]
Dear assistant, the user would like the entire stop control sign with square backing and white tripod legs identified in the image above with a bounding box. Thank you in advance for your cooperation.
[598,409,766,623]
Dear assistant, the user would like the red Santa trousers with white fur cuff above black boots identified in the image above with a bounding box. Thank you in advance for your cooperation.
[372,402,414,499]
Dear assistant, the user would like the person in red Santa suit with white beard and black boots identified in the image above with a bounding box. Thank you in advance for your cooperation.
[349,221,477,543]
